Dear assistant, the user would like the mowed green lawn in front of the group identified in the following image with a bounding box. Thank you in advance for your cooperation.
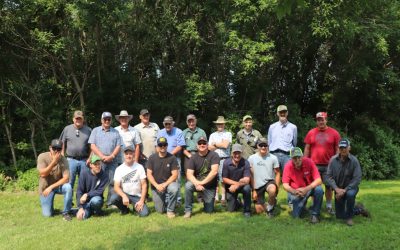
[0,180,400,250]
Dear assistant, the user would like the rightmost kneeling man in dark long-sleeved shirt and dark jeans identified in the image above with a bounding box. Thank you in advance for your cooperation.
[326,139,369,226]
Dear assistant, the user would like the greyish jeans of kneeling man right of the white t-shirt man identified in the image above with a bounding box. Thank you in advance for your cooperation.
[152,182,179,213]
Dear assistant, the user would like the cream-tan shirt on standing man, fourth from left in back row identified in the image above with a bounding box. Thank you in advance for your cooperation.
[134,122,160,158]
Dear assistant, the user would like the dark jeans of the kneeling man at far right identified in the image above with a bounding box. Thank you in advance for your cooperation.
[335,188,358,219]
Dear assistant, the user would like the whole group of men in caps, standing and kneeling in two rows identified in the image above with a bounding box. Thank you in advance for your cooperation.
[37,105,369,226]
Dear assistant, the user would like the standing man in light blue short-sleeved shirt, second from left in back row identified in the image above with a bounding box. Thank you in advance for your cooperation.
[89,112,122,206]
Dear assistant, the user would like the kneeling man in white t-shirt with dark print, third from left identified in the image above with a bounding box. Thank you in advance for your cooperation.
[111,146,149,217]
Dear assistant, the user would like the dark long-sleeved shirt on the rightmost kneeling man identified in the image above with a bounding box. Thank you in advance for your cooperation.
[327,154,362,190]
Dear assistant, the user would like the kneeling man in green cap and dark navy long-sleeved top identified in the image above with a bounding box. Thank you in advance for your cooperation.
[76,154,108,220]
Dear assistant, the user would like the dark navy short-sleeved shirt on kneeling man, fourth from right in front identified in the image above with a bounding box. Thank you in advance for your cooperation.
[222,158,251,189]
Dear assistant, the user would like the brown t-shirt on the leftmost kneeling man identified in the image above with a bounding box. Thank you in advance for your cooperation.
[37,152,69,194]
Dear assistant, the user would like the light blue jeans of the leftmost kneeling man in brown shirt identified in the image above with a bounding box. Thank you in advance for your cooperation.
[40,183,72,217]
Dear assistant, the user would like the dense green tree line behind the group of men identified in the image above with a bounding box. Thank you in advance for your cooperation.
[0,0,400,179]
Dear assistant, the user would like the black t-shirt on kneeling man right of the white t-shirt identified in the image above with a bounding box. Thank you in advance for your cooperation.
[146,153,179,189]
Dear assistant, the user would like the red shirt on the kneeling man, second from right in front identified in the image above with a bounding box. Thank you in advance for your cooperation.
[282,157,321,189]
